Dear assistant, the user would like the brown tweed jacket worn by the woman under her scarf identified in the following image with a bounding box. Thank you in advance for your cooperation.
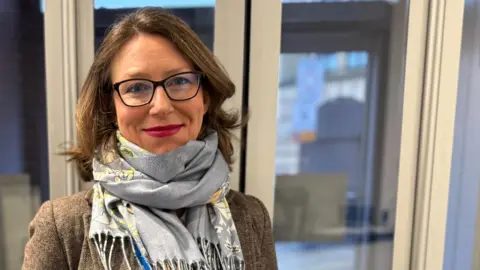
[23,190,277,270]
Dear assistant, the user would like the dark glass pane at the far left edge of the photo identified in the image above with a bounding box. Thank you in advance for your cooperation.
[0,0,49,270]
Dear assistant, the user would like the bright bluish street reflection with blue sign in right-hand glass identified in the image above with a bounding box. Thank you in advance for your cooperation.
[276,52,368,175]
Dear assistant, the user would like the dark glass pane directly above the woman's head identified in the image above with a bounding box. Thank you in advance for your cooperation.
[94,0,215,50]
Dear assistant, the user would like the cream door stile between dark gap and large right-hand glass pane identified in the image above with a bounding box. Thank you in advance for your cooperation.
[244,0,282,218]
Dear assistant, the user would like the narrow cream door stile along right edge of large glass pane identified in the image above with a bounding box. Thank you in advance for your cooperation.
[392,0,429,270]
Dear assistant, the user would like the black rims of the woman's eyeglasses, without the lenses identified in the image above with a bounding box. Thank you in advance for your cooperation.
[113,71,203,108]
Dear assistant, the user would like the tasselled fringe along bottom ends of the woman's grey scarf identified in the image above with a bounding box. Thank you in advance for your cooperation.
[91,231,245,270]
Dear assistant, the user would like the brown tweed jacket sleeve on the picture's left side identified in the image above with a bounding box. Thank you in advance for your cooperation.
[22,201,69,270]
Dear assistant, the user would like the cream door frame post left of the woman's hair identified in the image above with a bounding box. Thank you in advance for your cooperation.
[44,0,93,199]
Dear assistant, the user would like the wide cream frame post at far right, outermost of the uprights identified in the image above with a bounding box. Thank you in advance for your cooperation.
[411,0,464,270]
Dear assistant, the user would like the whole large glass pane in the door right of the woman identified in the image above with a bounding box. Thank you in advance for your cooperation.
[274,0,406,270]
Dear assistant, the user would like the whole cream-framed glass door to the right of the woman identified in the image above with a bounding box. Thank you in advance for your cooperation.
[245,0,426,270]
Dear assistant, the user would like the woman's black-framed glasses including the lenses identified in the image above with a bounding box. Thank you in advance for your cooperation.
[113,71,202,107]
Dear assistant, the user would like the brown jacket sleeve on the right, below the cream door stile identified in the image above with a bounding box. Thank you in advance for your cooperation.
[254,197,278,270]
